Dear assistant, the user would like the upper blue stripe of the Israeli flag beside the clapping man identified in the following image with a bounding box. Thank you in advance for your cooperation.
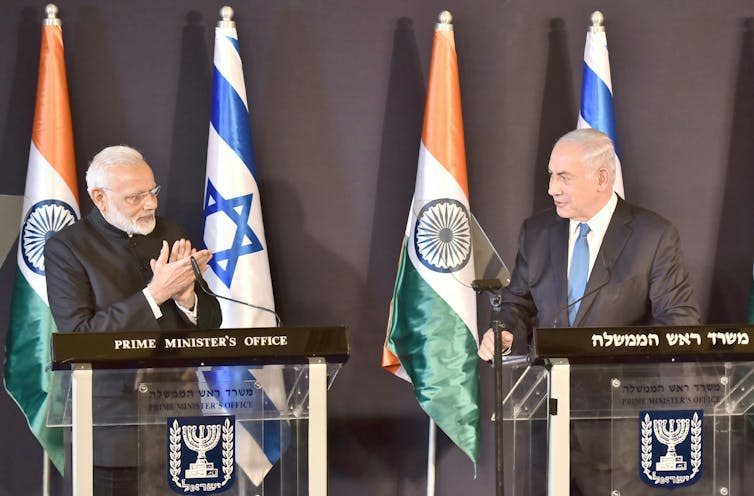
[212,67,257,181]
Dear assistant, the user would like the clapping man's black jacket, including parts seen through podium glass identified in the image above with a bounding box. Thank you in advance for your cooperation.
[45,209,222,466]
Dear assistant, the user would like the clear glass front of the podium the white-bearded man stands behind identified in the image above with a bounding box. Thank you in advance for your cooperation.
[48,364,340,496]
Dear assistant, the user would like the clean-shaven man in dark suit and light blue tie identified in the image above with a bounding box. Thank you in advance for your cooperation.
[479,129,699,495]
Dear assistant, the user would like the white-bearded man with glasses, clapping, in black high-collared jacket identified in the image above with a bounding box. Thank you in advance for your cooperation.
[44,146,222,495]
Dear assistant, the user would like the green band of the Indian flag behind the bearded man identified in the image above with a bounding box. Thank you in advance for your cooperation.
[5,269,65,474]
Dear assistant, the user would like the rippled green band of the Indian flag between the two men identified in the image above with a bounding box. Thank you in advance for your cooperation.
[387,240,481,470]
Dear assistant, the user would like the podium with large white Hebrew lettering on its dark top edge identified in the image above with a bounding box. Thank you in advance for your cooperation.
[503,326,754,496]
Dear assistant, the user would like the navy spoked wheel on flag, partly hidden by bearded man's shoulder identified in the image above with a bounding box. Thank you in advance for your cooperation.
[21,200,76,276]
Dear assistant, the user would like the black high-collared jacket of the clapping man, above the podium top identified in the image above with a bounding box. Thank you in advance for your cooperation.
[45,209,222,332]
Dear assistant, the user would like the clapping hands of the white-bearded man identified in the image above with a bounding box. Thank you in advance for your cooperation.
[147,239,212,308]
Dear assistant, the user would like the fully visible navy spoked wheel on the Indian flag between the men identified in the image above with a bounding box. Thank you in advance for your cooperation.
[414,198,471,272]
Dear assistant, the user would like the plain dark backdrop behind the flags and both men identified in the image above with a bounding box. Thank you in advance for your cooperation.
[0,0,754,496]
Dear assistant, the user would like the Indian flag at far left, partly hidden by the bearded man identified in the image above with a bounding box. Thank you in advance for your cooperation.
[5,6,80,473]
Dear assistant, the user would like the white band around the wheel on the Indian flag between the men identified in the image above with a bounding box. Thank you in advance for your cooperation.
[406,143,478,343]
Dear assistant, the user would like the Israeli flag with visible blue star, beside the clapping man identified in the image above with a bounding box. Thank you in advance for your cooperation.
[200,7,290,486]
